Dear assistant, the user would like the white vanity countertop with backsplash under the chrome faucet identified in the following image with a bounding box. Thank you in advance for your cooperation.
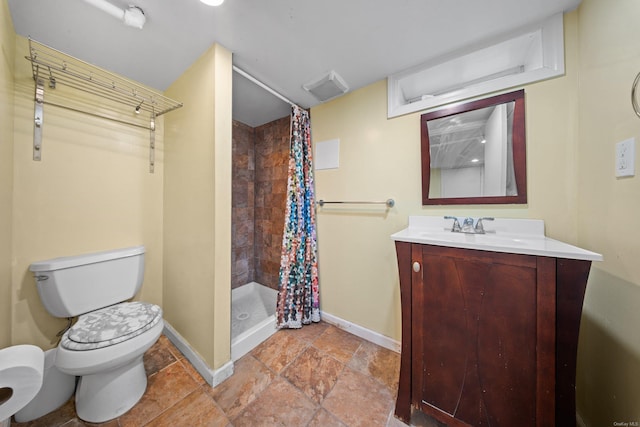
[391,216,602,261]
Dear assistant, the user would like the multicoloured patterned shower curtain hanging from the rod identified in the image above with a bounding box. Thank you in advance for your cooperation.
[276,106,320,328]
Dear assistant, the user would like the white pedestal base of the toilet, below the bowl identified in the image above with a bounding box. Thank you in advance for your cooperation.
[76,355,147,423]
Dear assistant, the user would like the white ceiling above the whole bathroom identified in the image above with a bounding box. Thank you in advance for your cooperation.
[8,0,580,126]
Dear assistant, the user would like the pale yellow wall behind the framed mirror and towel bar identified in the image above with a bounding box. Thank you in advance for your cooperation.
[311,12,584,340]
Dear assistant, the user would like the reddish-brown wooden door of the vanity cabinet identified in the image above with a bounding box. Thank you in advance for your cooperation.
[411,245,555,426]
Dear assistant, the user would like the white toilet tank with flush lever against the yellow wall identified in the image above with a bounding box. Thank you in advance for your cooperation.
[29,246,145,317]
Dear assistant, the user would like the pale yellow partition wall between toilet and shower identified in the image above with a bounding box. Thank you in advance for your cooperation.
[164,45,232,368]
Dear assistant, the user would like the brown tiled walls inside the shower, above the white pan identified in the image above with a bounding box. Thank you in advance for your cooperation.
[231,116,290,289]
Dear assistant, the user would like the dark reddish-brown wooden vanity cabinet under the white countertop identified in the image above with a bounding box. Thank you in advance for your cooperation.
[395,241,591,427]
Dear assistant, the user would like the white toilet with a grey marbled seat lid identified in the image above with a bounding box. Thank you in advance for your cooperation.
[29,246,164,423]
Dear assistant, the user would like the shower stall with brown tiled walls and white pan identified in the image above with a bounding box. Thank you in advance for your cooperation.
[231,116,290,361]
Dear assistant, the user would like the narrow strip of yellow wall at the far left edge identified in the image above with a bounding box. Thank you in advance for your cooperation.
[0,0,15,348]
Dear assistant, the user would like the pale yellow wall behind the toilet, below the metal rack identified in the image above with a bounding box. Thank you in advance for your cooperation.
[11,36,163,349]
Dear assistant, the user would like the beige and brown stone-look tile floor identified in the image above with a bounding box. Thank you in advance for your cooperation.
[11,322,429,427]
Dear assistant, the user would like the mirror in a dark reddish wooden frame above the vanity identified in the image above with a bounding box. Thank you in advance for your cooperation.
[420,90,527,205]
